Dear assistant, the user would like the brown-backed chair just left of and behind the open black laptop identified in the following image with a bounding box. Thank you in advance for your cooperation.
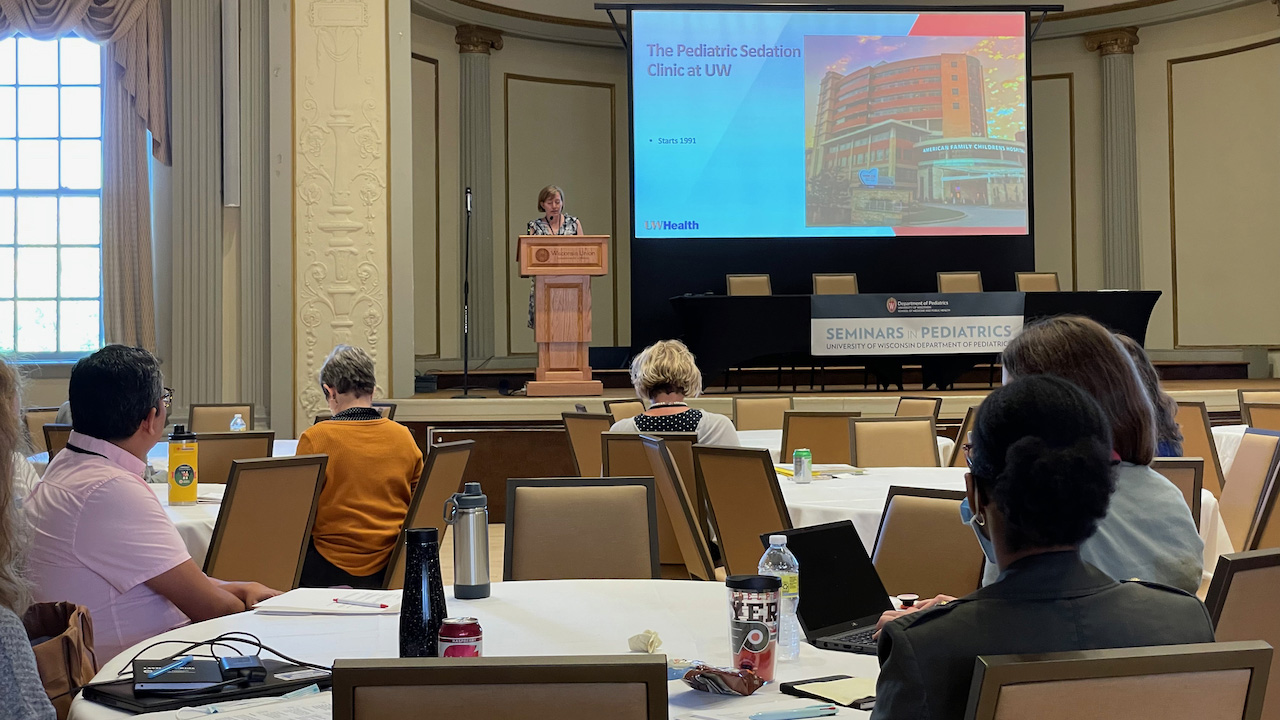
[694,445,791,575]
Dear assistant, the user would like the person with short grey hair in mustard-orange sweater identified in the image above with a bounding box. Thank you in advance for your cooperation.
[298,345,422,588]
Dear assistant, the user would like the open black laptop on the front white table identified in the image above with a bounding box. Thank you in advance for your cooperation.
[760,520,893,655]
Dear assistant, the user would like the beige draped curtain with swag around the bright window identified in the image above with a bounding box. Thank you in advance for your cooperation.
[0,0,170,351]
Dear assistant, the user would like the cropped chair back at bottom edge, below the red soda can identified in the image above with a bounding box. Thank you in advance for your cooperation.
[333,655,668,720]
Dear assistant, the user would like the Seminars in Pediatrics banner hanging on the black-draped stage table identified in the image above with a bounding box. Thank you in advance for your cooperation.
[809,292,1025,355]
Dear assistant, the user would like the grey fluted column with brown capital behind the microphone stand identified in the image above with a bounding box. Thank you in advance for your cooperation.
[453,24,506,359]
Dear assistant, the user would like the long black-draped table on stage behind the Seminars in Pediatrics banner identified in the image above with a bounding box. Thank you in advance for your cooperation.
[671,290,1160,387]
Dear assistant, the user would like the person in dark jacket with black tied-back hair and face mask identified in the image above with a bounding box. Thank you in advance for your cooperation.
[872,375,1213,720]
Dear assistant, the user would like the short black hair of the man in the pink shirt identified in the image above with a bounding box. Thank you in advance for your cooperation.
[67,345,164,441]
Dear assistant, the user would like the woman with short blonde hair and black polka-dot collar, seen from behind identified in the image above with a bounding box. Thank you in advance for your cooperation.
[609,340,740,447]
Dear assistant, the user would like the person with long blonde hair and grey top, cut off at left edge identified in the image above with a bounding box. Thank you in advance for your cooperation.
[0,360,58,720]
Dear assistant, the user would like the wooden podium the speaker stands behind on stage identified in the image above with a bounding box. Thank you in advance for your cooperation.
[517,234,609,397]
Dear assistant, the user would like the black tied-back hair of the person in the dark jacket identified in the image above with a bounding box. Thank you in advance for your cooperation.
[970,375,1115,552]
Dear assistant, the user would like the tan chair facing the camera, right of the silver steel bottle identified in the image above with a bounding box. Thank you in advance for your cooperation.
[502,477,660,580]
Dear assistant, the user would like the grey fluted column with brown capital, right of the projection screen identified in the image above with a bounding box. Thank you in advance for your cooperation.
[1084,27,1142,290]
